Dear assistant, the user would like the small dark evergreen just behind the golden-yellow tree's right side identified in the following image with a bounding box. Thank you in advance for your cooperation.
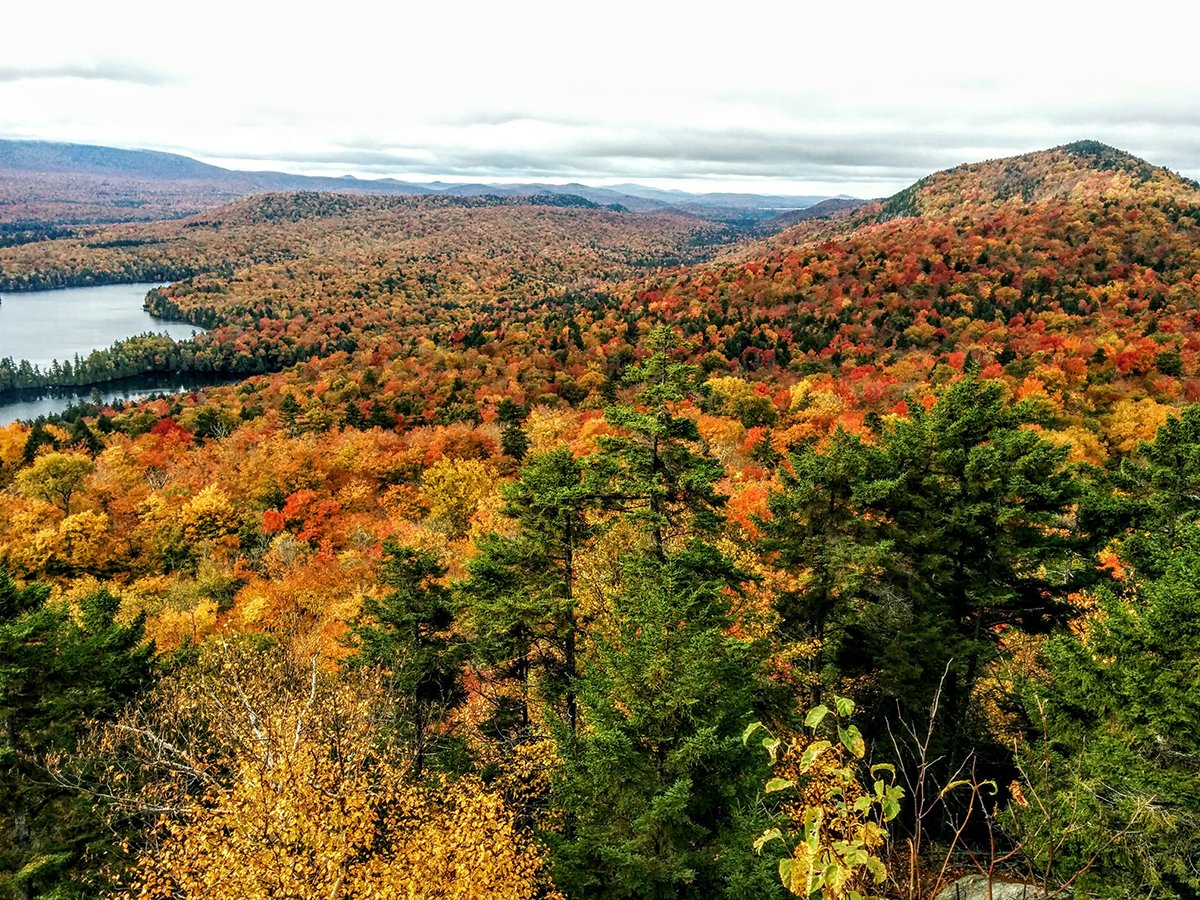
[348,541,466,775]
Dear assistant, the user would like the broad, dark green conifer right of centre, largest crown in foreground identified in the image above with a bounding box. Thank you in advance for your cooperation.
[860,377,1094,755]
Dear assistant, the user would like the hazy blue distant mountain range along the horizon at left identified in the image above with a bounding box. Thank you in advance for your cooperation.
[0,140,859,227]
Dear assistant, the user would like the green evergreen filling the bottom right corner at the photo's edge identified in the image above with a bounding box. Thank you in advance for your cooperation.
[1009,523,1200,900]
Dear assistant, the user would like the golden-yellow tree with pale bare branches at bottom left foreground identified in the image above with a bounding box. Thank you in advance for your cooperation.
[100,644,557,900]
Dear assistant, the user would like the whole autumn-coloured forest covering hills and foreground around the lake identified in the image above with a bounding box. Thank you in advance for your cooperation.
[0,142,1200,900]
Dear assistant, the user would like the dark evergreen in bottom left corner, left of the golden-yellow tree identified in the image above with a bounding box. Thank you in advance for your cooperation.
[0,570,154,899]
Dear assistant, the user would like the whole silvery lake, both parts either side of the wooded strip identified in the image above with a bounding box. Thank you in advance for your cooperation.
[0,283,211,426]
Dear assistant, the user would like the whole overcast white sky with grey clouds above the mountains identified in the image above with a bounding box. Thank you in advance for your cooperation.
[0,0,1200,197]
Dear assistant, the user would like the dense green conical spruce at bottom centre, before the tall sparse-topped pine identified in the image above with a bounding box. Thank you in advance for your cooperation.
[551,545,762,898]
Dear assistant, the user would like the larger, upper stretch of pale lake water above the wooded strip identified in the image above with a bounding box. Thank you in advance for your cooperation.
[0,284,200,368]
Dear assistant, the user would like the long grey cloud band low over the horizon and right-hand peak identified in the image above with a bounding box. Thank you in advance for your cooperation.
[177,104,1200,194]
